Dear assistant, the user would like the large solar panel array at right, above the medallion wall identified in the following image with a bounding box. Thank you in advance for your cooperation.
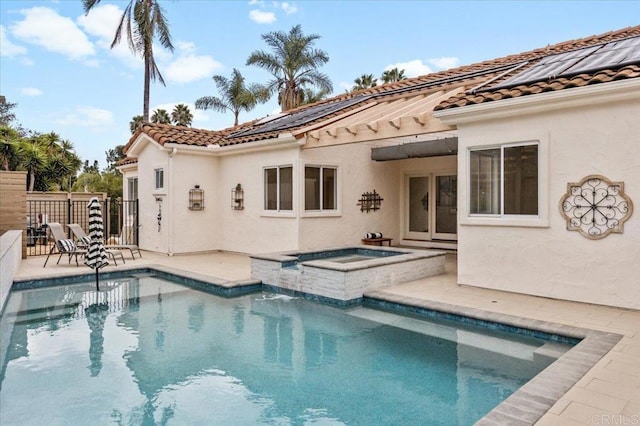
[485,37,640,90]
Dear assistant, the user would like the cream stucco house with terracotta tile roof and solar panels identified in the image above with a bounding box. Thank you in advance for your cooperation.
[119,26,640,309]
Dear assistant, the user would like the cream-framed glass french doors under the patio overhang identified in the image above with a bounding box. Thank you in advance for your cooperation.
[404,172,458,241]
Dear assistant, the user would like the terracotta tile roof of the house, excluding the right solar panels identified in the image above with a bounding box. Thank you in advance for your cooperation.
[124,25,640,153]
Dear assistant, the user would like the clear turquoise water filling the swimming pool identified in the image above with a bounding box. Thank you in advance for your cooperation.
[0,276,558,426]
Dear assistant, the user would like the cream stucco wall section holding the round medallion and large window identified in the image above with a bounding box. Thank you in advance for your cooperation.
[452,89,640,309]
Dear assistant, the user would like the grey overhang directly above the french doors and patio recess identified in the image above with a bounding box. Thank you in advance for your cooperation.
[371,137,458,161]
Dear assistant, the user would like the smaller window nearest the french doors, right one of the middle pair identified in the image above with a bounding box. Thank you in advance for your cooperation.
[304,166,337,211]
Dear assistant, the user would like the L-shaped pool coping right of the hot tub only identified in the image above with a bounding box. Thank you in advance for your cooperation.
[363,290,623,426]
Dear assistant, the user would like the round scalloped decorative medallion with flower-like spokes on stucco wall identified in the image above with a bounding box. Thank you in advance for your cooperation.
[560,175,633,240]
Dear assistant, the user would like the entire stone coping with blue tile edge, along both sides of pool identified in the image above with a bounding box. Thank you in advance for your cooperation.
[7,264,623,425]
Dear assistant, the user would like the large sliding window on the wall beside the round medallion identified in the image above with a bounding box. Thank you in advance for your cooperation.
[469,144,538,216]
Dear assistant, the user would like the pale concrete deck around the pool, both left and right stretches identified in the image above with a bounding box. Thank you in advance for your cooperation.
[10,252,640,426]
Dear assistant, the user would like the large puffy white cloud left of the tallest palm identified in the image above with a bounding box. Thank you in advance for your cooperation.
[10,7,95,60]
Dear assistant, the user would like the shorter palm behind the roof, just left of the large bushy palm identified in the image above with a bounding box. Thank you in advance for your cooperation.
[196,68,269,126]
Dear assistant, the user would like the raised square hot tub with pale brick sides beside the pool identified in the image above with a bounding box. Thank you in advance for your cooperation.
[251,246,446,305]
